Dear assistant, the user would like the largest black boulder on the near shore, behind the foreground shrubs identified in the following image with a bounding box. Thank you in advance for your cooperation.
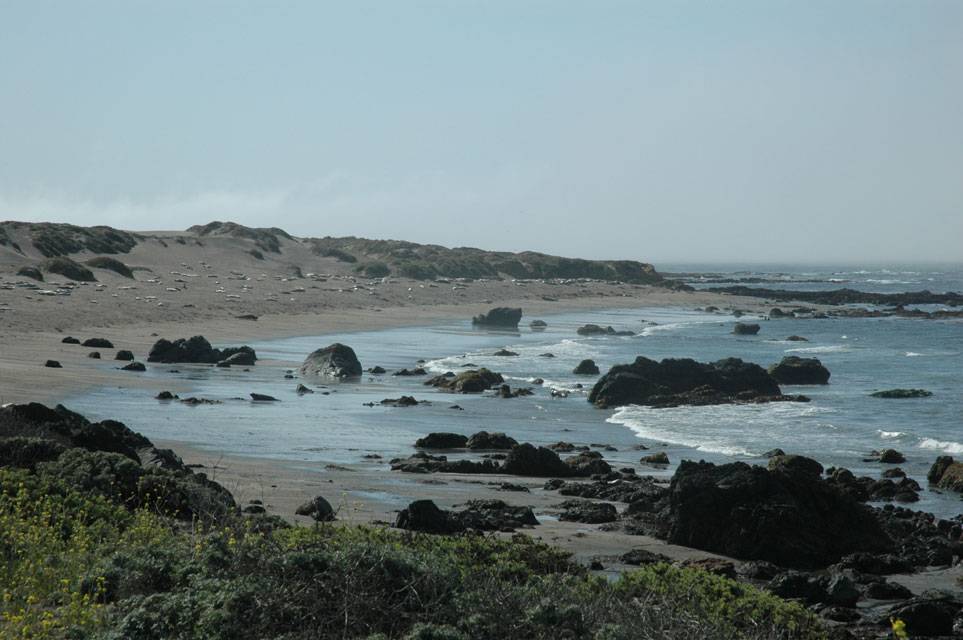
[654,461,894,569]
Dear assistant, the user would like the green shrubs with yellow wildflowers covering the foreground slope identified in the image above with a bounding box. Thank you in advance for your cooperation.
[0,464,823,640]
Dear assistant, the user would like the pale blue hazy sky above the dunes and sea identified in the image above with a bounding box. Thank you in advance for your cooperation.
[0,0,963,263]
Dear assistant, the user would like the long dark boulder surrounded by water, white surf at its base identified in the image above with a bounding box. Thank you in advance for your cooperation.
[589,356,780,409]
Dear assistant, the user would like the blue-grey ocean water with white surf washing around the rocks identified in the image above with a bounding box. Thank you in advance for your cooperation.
[65,265,963,517]
